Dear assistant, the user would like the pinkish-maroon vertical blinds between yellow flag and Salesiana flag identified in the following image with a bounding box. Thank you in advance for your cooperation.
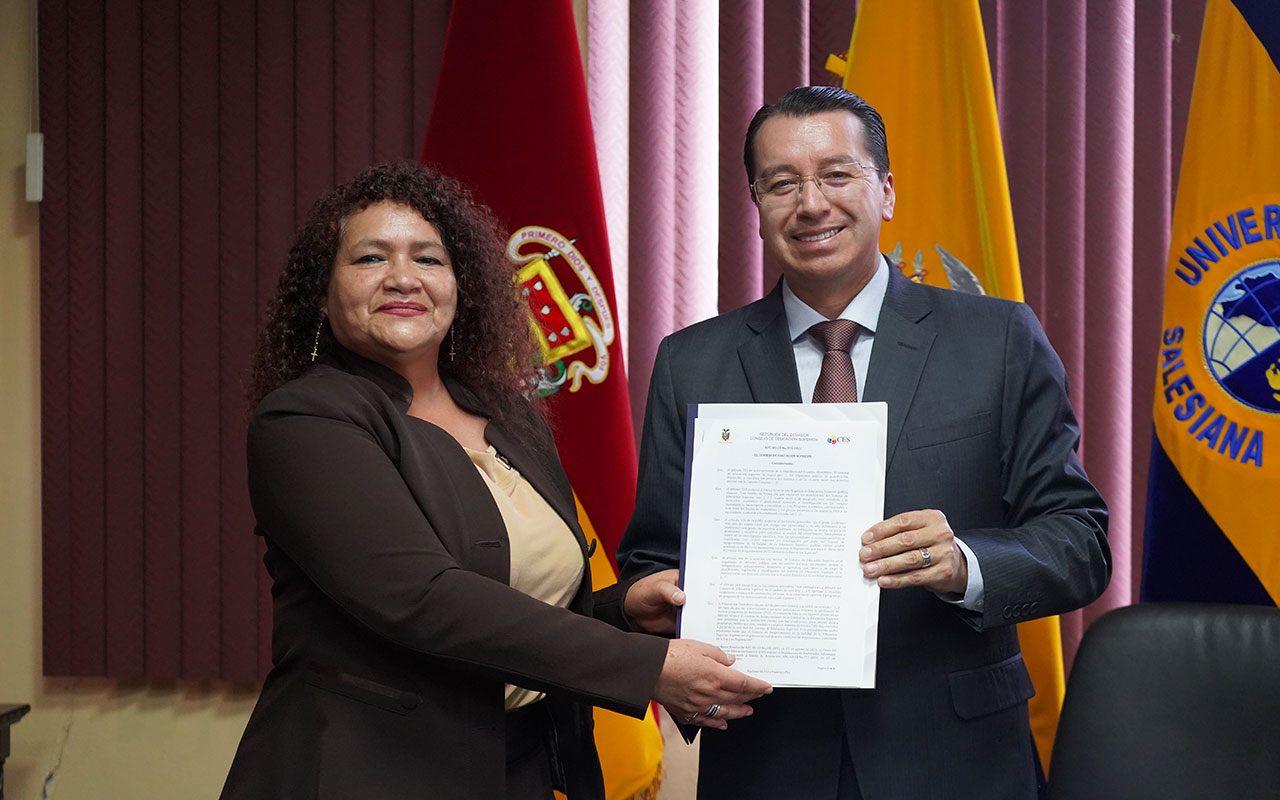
[982,0,1204,666]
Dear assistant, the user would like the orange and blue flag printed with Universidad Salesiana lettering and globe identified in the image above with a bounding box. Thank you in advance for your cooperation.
[1142,0,1280,605]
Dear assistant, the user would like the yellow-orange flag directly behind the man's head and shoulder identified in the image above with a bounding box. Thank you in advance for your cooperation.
[827,0,1066,769]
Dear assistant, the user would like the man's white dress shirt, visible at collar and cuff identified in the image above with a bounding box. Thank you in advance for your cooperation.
[782,259,983,612]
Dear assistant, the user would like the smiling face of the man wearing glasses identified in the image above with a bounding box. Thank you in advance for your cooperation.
[754,111,893,314]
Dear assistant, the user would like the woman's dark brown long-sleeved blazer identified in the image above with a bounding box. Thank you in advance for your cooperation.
[221,349,667,800]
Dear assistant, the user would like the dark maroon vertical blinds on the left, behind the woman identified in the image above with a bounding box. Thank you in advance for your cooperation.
[40,0,448,680]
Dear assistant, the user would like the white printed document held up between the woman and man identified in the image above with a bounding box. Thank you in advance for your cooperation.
[680,403,887,687]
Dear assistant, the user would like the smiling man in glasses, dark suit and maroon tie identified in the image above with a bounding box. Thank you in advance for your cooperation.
[618,87,1111,800]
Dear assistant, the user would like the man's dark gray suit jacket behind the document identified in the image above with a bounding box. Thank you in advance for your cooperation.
[618,269,1111,800]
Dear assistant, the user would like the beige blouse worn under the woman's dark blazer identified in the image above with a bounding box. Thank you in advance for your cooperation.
[463,444,584,710]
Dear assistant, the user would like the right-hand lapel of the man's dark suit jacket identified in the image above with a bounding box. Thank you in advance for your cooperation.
[863,268,937,468]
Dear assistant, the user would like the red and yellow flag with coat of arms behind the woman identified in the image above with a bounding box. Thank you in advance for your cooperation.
[422,0,662,800]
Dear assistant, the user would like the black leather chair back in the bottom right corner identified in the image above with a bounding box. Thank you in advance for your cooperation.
[1048,603,1280,800]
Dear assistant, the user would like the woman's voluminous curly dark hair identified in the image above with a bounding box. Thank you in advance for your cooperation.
[248,163,538,420]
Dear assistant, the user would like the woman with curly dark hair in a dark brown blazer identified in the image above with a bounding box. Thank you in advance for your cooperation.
[223,164,769,800]
